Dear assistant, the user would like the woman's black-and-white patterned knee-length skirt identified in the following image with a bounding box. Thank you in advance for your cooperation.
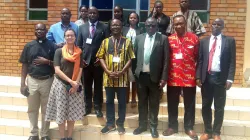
[45,77,85,124]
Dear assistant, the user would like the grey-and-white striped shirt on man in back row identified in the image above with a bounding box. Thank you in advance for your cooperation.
[167,10,206,35]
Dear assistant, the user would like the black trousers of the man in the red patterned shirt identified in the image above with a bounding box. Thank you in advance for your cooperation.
[167,86,196,132]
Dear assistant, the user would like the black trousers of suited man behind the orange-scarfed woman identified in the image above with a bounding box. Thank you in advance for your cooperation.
[83,64,103,110]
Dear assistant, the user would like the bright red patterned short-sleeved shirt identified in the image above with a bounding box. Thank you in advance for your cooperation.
[168,32,199,87]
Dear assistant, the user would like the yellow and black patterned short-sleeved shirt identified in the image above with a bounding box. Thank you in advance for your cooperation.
[96,37,135,87]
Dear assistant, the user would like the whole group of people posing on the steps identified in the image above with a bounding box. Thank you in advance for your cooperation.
[19,0,236,140]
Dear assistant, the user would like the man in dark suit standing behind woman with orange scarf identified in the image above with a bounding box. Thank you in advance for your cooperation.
[77,6,108,117]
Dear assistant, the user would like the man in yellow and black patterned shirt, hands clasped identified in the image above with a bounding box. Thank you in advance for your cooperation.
[96,19,135,134]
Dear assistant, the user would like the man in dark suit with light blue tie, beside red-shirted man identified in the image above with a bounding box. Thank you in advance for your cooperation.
[132,17,169,138]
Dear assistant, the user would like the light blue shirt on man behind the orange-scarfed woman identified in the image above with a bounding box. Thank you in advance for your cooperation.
[46,22,78,44]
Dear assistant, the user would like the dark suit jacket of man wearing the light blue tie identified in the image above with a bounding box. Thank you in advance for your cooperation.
[132,33,169,83]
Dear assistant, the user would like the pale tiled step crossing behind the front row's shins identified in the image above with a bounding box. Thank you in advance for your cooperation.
[0,99,250,121]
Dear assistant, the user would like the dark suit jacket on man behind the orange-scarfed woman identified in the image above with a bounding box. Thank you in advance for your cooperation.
[77,22,108,64]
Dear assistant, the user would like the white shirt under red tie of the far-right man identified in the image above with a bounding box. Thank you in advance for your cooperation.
[209,34,221,72]
